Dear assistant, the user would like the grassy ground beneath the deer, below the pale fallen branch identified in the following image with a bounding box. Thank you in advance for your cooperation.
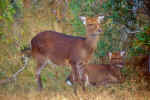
[0,61,150,100]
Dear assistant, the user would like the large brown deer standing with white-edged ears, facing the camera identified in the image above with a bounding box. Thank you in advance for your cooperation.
[21,16,104,92]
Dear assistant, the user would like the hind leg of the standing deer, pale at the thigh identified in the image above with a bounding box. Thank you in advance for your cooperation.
[36,61,47,91]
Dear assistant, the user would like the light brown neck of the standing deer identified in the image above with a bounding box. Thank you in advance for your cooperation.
[86,33,99,50]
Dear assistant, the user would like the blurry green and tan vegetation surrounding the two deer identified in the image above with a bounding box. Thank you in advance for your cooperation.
[0,0,150,100]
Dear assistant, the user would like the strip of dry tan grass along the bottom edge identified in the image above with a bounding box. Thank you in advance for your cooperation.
[0,88,150,100]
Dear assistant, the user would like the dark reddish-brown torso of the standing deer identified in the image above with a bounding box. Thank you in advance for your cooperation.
[31,31,97,65]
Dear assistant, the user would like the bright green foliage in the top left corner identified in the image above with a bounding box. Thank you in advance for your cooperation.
[0,0,22,32]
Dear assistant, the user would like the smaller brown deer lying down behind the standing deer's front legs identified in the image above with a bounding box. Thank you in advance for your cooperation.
[66,51,125,86]
